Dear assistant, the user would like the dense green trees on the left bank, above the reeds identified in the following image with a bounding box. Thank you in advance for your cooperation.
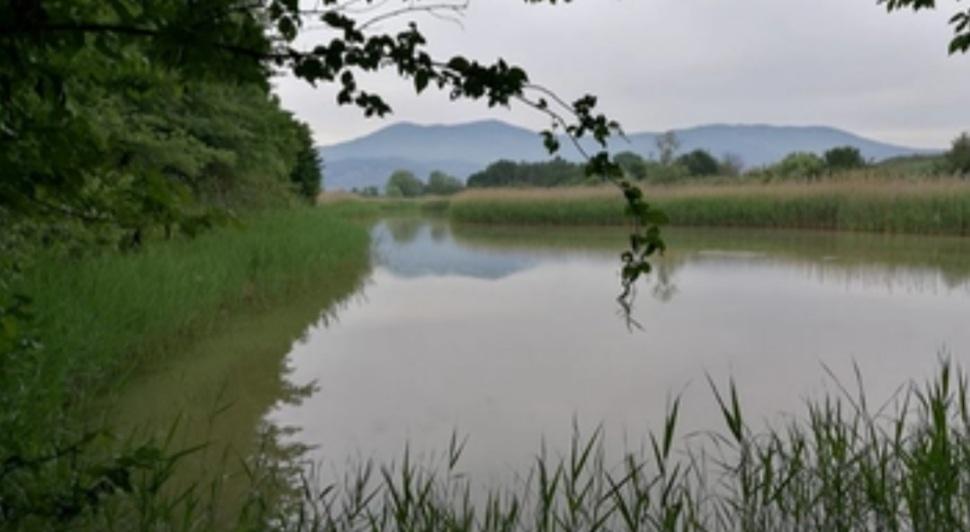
[0,2,319,249]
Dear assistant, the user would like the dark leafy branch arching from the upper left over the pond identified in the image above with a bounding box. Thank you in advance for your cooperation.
[0,0,672,320]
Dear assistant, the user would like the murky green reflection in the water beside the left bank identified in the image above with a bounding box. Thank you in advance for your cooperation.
[111,265,368,513]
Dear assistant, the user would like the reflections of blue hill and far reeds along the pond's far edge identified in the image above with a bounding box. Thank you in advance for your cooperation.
[372,217,970,301]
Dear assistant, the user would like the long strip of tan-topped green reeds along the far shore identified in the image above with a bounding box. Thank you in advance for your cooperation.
[449,180,970,235]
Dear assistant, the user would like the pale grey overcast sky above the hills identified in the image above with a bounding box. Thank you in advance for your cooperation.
[277,0,970,147]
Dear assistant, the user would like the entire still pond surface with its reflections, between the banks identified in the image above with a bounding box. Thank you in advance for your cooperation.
[123,218,970,481]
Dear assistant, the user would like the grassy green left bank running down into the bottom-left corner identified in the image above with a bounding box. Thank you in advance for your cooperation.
[0,207,369,529]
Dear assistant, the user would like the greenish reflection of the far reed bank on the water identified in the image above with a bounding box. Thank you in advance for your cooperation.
[452,225,970,301]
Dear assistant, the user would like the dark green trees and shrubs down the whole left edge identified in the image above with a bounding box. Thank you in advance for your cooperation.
[0,0,328,522]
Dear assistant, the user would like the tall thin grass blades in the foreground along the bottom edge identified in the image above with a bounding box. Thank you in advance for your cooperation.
[58,362,970,531]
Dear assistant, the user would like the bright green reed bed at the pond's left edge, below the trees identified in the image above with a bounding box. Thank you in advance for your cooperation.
[11,208,369,440]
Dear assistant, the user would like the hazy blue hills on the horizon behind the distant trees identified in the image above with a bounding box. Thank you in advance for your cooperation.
[320,120,933,190]
